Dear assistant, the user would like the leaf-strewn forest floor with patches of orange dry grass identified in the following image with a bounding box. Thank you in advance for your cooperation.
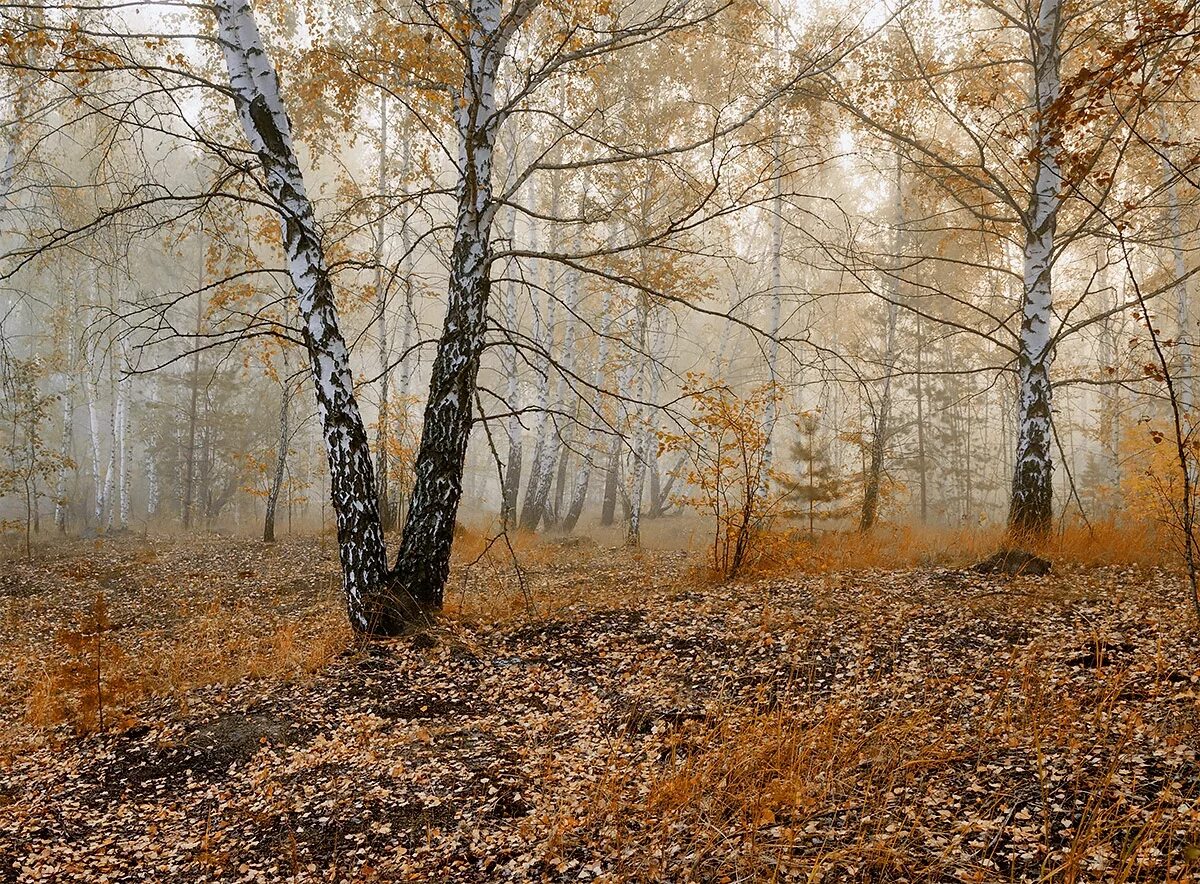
[0,527,1200,882]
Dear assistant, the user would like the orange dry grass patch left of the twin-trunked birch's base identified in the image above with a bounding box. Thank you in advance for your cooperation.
[0,537,353,741]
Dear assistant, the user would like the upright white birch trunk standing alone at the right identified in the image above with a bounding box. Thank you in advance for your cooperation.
[1008,0,1062,535]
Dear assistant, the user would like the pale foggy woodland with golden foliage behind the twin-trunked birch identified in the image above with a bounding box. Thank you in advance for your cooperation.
[0,2,1196,568]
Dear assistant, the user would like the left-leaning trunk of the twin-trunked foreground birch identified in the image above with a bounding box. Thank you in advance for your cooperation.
[215,0,386,633]
